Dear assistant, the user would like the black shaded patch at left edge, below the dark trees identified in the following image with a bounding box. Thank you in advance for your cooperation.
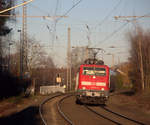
[0,71,31,100]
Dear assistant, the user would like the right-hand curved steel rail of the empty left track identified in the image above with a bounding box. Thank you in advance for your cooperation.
[57,94,74,125]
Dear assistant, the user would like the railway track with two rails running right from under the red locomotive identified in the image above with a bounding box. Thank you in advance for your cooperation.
[85,105,145,125]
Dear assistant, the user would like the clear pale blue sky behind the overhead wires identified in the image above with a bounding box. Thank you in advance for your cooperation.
[9,0,150,65]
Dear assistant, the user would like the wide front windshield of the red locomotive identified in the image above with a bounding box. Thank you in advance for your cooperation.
[83,67,106,76]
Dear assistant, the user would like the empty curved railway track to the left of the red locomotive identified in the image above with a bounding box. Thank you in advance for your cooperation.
[39,94,74,125]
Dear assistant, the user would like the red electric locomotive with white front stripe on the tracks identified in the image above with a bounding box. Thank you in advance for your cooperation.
[76,61,110,104]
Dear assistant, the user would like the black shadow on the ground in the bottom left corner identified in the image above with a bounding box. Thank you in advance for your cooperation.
[0,106,43,125]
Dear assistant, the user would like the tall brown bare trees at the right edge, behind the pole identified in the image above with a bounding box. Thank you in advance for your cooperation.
[129,28,150,91]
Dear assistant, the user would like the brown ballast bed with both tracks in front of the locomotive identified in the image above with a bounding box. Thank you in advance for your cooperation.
[39,94,146,125]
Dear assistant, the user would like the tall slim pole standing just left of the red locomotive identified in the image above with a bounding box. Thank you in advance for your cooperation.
[67,27,72,90]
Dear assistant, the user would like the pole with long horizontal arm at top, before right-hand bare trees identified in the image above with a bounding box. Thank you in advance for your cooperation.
[114,15,150,90]
